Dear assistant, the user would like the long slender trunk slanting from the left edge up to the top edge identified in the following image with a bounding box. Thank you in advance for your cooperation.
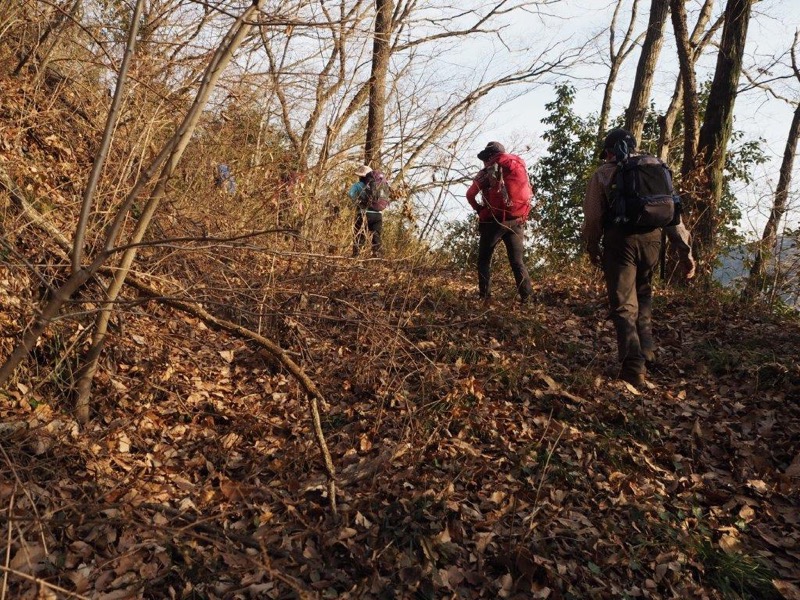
[0,0,263,385]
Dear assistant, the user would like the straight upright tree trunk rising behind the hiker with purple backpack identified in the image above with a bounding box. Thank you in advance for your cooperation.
[364,0,394,167]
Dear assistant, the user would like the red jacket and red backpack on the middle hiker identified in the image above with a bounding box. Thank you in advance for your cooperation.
[467,153,533,223]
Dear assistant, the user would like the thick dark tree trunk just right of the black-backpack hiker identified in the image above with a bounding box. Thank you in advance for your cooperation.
[694,0,753,268]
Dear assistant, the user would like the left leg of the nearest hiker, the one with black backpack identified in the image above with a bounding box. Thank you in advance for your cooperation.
[603,230,645,377]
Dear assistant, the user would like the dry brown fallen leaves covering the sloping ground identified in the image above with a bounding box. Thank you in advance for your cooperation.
[0,246,800,599]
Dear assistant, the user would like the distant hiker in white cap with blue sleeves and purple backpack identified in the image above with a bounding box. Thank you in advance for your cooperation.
[347,165,391,258]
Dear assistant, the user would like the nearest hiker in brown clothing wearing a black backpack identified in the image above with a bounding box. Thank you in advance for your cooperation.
[582,129,695,386]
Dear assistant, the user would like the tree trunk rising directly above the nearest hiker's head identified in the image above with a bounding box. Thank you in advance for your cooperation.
[625,0,669,140]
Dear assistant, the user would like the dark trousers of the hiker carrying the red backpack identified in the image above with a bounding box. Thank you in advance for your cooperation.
[478,220,531,302]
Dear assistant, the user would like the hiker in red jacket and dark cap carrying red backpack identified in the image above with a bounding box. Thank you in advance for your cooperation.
[467,142,533,304]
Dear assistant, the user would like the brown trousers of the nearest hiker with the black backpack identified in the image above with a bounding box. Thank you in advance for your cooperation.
[603,228,661,374]
